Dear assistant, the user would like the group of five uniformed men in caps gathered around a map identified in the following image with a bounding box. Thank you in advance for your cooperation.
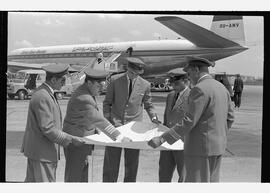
[21,57,234,182]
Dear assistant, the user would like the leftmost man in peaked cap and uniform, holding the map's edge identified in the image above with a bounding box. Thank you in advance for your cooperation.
[21,64,85,182]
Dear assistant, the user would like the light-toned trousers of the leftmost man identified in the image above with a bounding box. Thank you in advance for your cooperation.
[25,158,57,182]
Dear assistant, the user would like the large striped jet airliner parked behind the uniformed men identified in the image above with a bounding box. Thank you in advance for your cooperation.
[8,16,247,76]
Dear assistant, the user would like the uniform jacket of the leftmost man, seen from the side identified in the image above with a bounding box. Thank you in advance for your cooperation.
[21,84,71,162]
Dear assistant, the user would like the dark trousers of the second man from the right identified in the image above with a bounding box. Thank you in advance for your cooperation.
[159,150,185,182]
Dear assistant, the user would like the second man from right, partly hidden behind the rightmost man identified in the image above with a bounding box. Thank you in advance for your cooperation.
[159,68,190,182]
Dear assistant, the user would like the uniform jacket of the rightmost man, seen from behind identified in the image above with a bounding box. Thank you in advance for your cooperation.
[163,75,234,156]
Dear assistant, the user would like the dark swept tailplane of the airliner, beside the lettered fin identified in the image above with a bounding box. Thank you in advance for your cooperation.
[155,16,240,48]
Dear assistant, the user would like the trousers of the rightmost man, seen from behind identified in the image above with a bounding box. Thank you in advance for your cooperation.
[184,155,222,182]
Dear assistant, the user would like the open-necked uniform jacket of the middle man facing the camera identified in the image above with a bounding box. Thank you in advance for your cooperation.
[103,73,155,127]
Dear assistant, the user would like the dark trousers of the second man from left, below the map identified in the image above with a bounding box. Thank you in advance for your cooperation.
[64,144,93,182]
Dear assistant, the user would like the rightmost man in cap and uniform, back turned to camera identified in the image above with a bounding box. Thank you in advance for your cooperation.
[148,57,234,182]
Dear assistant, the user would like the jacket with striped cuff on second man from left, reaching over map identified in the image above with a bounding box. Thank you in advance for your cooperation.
[63,83,120,140]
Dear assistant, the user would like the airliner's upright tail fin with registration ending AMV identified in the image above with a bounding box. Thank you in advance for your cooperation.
[211,15,245,45]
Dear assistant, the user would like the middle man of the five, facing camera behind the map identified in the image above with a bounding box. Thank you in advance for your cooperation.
[103,57,158,182]
